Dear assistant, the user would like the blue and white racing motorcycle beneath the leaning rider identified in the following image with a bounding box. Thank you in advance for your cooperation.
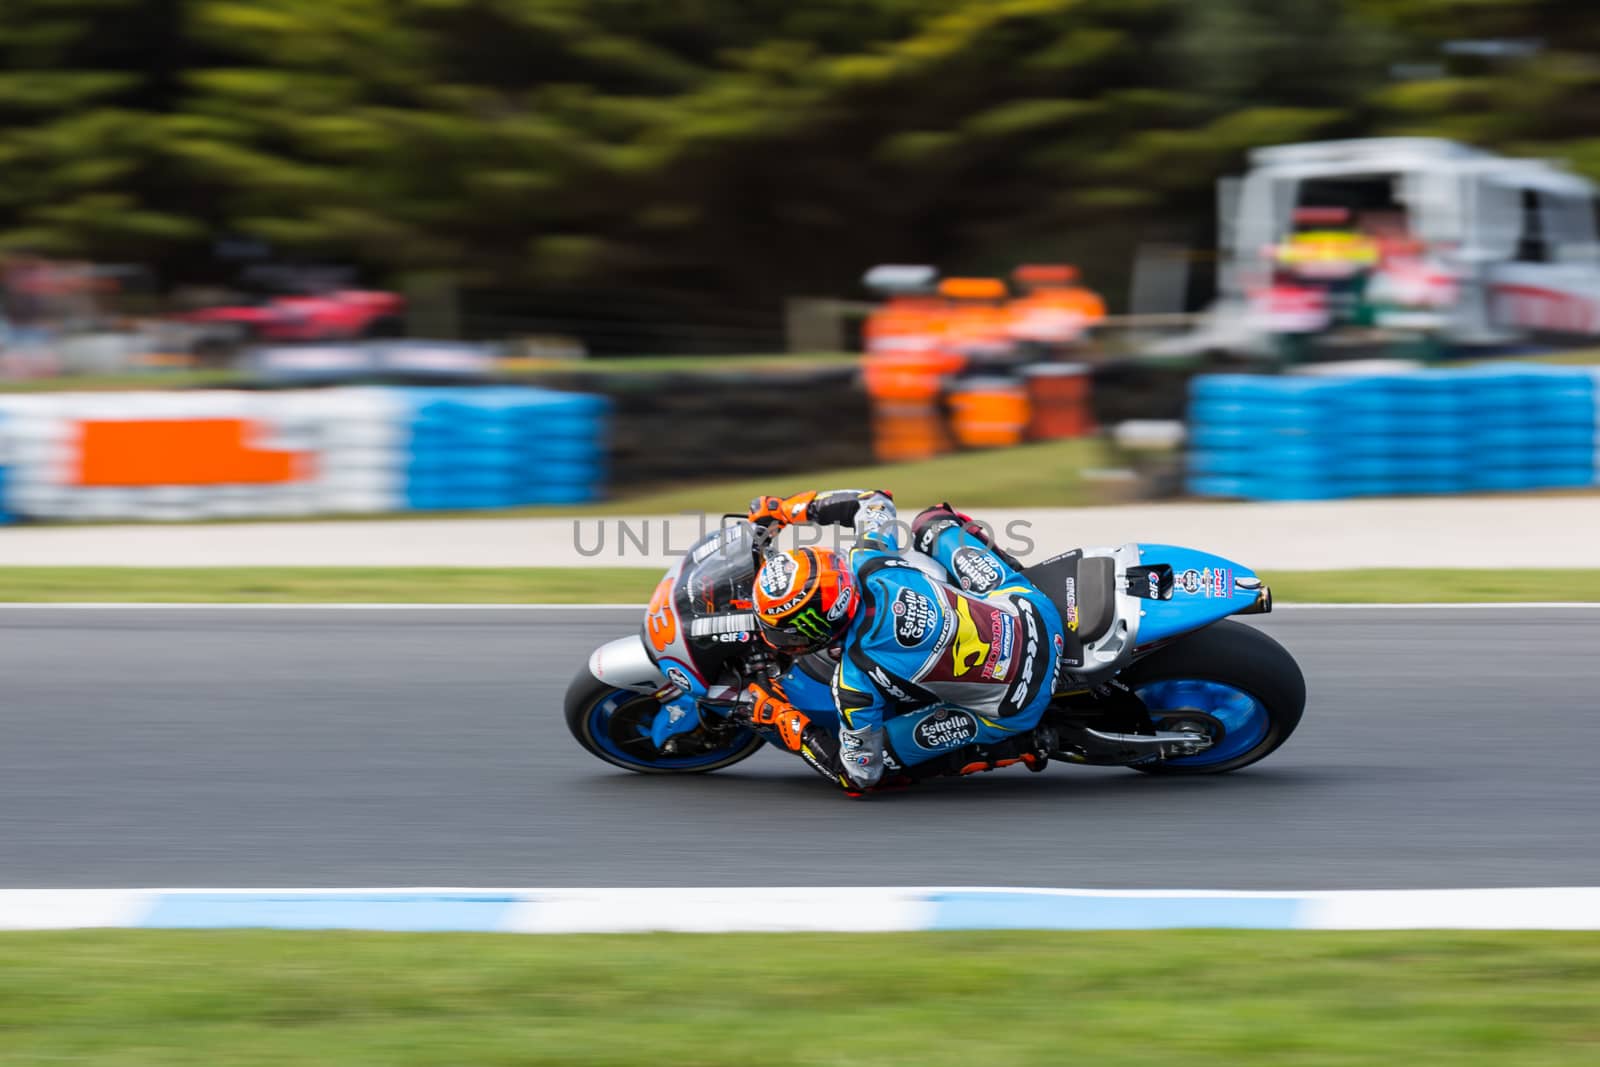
[566,517,1306,782]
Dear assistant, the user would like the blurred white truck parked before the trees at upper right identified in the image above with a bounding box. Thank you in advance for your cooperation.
[1209,138,1600,347]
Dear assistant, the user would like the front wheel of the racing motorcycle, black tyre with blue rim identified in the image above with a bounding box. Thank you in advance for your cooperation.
[566,667,765,774]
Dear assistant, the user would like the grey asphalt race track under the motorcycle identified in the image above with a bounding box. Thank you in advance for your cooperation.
[0,608,1600,889]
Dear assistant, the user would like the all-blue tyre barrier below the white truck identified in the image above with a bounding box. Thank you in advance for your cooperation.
[1189,365,1600,501]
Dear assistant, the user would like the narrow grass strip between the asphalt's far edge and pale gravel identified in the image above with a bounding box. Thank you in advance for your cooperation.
[0,566,1600,603]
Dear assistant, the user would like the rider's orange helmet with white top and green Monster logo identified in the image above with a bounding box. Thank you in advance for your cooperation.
[755,549,861,656]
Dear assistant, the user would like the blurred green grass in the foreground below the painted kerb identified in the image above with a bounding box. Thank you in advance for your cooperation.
[0,931,1600,1067]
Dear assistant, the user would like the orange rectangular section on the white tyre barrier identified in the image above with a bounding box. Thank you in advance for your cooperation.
[75,419,312,486]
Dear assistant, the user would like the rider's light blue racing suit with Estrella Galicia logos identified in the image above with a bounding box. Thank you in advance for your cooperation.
[813,493,1062,787]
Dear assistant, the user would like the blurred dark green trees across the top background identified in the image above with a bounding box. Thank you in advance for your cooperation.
[0,0,1600,315]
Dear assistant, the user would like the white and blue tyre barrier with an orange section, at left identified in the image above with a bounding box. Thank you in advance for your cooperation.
[0,387,606,520]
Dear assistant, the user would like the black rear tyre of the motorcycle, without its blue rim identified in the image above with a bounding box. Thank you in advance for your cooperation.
[1120,619,1306,774]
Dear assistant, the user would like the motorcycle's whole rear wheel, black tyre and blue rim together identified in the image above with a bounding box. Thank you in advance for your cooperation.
[1122,619,1306,774]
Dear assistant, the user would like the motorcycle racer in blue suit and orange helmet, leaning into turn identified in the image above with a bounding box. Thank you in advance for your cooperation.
[747,490,1062,795]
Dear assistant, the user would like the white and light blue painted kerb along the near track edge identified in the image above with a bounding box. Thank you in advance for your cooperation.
[9,886,1600,934]
